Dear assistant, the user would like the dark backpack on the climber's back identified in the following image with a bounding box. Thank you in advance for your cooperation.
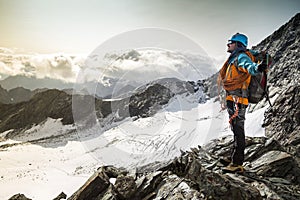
[246,50,273,106]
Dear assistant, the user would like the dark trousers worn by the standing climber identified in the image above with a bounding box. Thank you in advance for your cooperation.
[227,101,247,165]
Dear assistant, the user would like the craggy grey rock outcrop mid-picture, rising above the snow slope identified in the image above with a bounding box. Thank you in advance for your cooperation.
[105,78,194,120]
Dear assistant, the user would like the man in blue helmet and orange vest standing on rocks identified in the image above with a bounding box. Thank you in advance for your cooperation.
[218,33,267,172]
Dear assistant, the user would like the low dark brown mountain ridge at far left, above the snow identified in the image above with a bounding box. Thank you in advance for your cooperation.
[0,89,111,135]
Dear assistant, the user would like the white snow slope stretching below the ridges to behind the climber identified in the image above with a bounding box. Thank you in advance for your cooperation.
[0,94,265,200]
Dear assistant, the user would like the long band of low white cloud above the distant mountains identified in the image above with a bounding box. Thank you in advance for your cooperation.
[0,49,216,86]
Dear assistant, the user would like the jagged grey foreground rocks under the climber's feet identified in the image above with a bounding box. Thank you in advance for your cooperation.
[68,134,300,200]
